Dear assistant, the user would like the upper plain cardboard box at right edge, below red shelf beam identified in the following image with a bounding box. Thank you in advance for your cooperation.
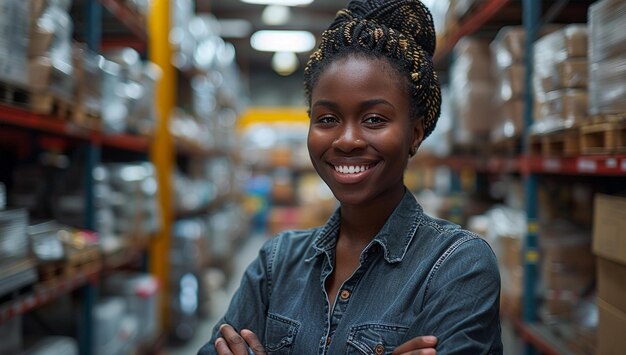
[593,194,626,264]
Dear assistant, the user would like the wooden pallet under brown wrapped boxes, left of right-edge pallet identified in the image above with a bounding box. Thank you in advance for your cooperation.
[529,127,580,156]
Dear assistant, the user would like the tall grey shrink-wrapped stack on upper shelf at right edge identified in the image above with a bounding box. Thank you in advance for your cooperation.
[588,0,626,115]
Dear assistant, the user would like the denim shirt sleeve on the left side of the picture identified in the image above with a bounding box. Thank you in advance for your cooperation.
[198,238,276,355]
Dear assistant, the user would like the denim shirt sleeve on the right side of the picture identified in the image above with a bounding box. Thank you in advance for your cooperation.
[414,238,502,354]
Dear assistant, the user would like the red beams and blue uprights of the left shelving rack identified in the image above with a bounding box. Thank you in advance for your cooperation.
[0,0,166,355]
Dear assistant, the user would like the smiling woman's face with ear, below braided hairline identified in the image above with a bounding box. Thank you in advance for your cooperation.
[308,56,424,205]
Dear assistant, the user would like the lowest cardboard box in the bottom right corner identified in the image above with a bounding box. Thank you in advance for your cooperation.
[598,298,626,355]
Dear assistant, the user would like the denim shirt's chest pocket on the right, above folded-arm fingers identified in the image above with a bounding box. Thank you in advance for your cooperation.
[346,324,408,355]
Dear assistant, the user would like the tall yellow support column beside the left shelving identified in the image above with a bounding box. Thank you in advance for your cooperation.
[148,0,176,330]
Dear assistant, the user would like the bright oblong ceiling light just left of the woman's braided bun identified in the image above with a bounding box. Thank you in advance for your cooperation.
[250,31,315,53]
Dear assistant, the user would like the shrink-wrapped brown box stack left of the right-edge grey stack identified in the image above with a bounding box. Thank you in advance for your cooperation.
[532,24,588,133]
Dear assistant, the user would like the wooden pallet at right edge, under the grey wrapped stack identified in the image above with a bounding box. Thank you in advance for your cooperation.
[580,120,626,154]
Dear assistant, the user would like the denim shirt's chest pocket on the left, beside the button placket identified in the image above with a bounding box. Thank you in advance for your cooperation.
[265,313,300,355]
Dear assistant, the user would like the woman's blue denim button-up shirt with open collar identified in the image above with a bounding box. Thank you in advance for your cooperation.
[198,191,502,355]
